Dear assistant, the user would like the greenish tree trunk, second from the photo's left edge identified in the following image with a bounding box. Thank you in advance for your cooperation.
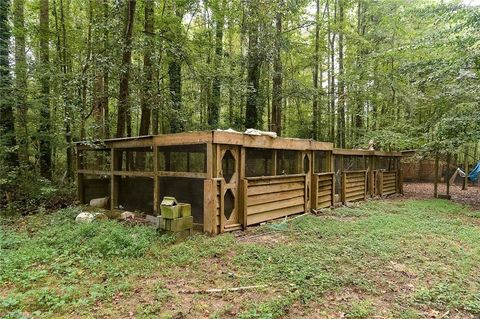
[13,0,29,165]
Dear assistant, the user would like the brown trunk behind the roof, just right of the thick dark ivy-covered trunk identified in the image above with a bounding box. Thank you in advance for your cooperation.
[271,1,283,136]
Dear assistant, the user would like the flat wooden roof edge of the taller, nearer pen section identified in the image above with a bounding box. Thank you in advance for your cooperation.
[75,131,333,151]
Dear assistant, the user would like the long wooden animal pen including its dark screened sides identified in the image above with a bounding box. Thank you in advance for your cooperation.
[76,131,400,234]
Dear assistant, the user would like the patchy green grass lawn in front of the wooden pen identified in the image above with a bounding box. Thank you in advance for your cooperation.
[0,200,480,318]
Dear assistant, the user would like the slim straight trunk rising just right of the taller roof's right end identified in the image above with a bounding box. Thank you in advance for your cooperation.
[337,0,345,148]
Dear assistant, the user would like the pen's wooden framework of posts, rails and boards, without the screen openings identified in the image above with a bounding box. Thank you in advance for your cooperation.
[76,131,402,234]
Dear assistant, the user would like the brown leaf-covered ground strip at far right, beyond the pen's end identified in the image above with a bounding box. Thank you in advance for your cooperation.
[403,182,480,209]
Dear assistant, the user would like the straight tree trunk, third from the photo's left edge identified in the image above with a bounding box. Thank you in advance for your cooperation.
[38,0,52,179]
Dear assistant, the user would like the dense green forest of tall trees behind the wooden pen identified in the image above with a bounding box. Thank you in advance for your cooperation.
[0,0,480,200]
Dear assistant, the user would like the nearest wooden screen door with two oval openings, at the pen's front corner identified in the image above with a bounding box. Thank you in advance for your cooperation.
[216,145,243,232]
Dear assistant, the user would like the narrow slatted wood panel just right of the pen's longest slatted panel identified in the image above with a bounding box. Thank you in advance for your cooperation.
[312,172,335,209]
